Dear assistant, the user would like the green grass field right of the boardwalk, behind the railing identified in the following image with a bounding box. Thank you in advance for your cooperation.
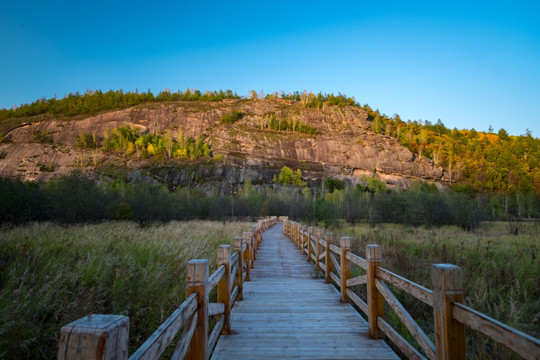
[334,222,540,359]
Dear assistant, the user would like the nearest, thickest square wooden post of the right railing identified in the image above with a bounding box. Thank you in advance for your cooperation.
[431,264,467,360]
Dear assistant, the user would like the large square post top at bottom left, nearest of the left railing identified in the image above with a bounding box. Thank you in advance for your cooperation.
[58,314,129,360]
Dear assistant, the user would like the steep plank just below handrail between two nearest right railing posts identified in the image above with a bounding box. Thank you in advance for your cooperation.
[375,279,437,359]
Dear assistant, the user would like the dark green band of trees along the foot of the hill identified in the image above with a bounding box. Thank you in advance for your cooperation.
[0,168,540,228]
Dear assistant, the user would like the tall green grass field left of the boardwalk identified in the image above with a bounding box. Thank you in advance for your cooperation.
[0,221,253,359]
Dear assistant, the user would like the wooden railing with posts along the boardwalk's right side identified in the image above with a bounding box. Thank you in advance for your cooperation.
[283,219,540,359]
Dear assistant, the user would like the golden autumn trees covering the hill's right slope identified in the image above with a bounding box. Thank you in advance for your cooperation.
[368,109,540,195]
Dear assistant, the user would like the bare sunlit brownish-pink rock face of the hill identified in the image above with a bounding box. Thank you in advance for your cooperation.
[0,100,447,187]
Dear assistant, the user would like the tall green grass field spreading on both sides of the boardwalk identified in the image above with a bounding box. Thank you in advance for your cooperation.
[0,221,540,359]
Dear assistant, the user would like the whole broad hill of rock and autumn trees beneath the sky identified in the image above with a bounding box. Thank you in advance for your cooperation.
[0,90,540,194]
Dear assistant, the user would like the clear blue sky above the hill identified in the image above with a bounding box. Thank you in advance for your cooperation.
[0,0,540,137]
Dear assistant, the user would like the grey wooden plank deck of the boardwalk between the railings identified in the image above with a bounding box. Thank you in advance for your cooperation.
[212,224,399,360]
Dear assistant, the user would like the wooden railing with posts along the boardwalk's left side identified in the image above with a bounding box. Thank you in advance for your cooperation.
[58,217,277,360]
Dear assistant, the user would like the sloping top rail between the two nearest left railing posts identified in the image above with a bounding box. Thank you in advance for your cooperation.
[129,294,197,360]
